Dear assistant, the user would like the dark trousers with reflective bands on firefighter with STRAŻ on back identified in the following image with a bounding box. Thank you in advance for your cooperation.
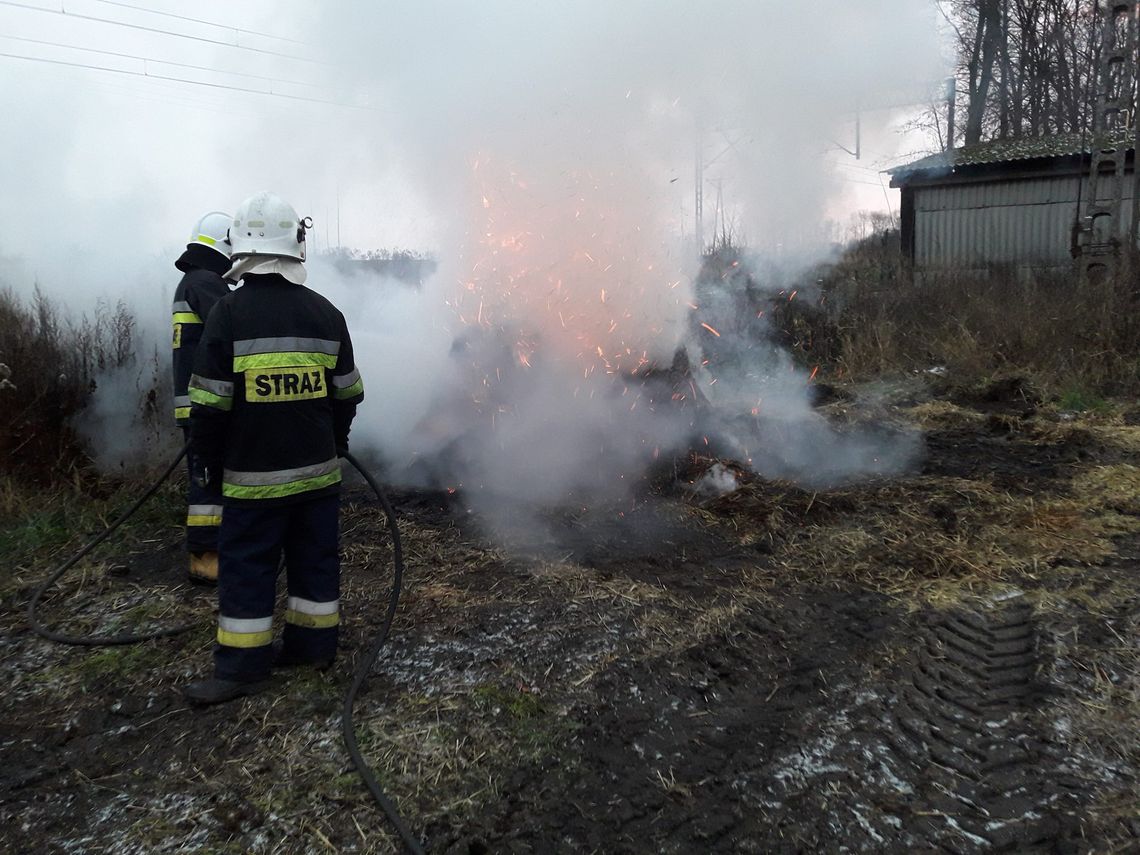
[214,495,341,682]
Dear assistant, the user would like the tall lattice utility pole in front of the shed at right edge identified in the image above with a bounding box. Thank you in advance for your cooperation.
[1076,0,1140,282]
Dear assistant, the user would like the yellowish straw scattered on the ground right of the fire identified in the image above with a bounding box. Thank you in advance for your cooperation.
[694,401,1140,604]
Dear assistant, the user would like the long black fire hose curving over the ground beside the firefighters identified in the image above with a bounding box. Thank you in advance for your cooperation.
[26,443,424,855]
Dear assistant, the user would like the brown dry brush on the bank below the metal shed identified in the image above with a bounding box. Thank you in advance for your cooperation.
[773,221,1140,398]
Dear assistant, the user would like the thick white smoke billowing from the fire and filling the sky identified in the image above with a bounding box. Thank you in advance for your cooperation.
[0,0,942,503]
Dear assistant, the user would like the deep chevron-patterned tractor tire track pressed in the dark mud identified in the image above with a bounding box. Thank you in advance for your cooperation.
[888,601,1076,852]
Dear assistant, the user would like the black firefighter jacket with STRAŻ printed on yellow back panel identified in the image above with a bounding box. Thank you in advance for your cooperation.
[189,274,364,504]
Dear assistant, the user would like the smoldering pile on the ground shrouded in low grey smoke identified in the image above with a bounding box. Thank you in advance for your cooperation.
[378,285,920,513]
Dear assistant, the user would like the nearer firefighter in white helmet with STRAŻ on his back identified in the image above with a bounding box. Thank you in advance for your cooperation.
[185,193,364,703]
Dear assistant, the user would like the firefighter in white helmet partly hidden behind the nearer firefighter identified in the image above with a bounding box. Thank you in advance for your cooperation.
[171,211,231,585]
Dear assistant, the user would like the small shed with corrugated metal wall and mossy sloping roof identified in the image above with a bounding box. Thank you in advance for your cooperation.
[889,135,1133,271]
